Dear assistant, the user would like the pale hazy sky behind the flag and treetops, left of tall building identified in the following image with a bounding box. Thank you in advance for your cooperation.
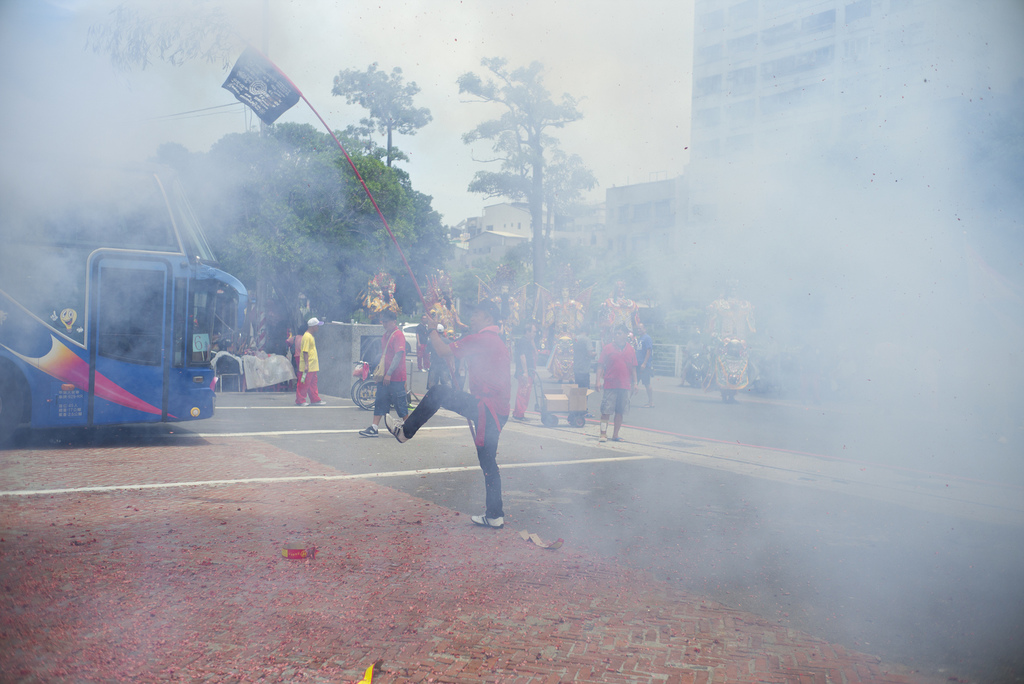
[0,0,693,224]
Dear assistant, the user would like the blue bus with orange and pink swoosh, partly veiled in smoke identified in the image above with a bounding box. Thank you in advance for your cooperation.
[0,167,247,443]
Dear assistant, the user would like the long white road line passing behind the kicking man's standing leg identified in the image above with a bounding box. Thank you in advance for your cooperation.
[0,456,651,497]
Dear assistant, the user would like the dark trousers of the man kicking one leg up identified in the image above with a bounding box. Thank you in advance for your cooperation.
[404,385,508,518]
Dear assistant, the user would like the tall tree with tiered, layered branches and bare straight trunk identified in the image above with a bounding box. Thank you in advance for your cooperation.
[458,57,583,285]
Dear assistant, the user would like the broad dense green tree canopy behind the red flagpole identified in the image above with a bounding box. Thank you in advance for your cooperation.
[160,124,451,319]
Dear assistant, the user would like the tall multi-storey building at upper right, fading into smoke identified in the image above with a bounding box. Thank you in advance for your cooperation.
[689,0,983,223]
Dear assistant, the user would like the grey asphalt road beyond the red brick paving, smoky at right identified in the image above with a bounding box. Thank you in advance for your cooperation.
[8,378,1024,681]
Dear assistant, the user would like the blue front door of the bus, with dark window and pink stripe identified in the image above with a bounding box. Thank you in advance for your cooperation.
[89,254,171,425]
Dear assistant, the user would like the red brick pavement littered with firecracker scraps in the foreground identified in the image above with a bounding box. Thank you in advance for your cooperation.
[0,438,934,684]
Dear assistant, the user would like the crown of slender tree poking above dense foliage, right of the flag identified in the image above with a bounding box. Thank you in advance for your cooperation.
[331,61,432,166]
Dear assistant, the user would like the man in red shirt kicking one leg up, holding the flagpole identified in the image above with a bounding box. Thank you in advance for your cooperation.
[384,300,512,527]
